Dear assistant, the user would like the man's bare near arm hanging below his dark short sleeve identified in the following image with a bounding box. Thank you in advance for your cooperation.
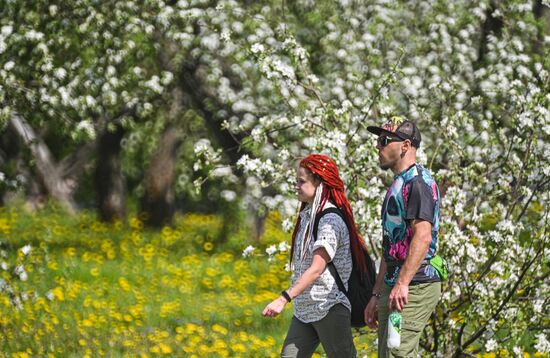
[388,220,432,311]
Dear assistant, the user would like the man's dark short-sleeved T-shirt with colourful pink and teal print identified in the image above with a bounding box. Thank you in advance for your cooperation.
[382,164,441,286]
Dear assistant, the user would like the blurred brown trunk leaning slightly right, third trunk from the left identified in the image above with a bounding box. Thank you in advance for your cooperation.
[141,123,182,227]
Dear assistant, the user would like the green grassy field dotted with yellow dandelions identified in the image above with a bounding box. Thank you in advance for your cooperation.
[0,209,375,357]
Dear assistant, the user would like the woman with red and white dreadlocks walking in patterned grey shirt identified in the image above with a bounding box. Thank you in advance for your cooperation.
[262,154,366,357]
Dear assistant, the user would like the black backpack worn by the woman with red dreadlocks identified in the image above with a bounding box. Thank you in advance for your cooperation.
[313,208,376,327]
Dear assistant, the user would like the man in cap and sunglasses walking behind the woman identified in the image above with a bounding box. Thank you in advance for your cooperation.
[365,117,441,357]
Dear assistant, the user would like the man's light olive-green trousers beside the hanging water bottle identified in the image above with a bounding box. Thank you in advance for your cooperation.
[378,282,441,358]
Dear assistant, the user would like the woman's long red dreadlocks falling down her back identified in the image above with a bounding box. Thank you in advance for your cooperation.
[290,154,368,272]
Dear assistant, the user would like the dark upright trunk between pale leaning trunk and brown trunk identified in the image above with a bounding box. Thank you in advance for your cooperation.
[95,125,126,221]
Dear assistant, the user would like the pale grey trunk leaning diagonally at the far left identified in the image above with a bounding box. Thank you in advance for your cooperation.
[9,114,76,214]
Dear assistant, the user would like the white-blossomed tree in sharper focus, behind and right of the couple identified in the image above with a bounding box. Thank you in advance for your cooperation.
[201,1,550,356]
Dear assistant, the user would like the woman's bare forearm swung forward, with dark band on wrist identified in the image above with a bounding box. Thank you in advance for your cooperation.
[262,247,330,317]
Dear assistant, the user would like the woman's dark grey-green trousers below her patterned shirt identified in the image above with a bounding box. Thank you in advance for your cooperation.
[281,304,357,358]
